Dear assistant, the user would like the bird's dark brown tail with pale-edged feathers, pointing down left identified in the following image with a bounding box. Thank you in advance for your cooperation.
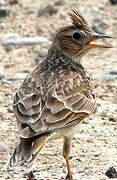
[7,134,48,172]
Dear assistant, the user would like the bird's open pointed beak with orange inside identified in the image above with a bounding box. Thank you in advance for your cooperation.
[85,34,112,48]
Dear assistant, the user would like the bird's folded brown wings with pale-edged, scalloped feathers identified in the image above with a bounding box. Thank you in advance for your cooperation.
[14,71,96,136]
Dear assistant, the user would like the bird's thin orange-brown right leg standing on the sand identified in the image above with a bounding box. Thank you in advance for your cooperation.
[63,137,73,180]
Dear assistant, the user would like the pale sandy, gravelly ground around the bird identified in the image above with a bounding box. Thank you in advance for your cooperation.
[0,0,117,180]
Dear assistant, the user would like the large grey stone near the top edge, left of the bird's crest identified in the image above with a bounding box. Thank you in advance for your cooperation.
[37,4,57,17]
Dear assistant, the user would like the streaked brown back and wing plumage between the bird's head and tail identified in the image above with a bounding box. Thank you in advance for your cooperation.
[14,47,96,134]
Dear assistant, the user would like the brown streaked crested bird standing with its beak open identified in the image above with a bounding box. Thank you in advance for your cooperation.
[7,10,111,180]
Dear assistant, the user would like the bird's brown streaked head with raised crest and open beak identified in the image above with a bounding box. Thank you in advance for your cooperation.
[53,10,111,58]
